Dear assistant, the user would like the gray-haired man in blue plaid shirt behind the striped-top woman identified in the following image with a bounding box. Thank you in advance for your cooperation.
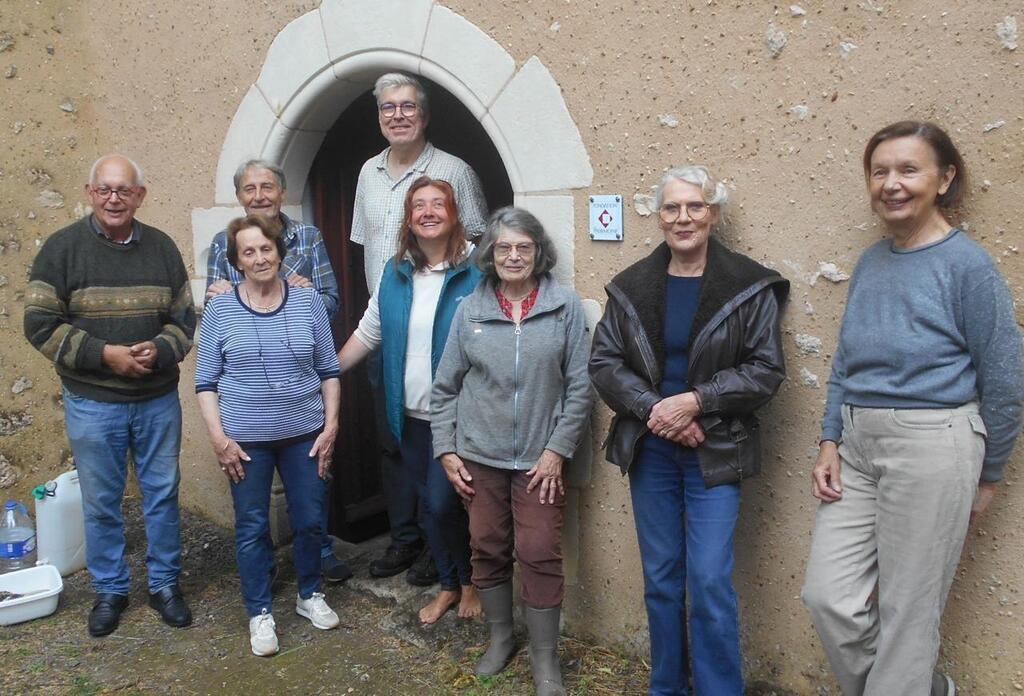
[206,160,352,582]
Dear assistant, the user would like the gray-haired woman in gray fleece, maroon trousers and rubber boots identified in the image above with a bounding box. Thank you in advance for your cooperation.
[430,208,592,694]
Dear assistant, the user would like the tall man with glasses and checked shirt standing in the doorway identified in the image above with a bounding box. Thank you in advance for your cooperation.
[350,73,487,585]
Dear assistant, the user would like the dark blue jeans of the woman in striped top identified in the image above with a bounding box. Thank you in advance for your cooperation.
[230,437,327,616]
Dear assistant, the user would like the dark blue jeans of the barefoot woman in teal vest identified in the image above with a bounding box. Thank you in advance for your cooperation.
[401,418,472,590]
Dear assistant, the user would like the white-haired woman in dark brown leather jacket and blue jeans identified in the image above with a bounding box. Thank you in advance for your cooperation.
[590,166,790,696]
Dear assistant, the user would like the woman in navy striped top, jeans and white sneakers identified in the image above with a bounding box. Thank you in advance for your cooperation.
[196,215,340,655]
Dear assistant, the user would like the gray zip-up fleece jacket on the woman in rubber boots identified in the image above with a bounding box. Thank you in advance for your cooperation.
[430,275,593,470]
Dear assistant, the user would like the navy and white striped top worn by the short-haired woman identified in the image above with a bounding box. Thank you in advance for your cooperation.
[196,284,340,442]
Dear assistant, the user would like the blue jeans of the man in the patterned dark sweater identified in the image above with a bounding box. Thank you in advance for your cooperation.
[63,389,181,595]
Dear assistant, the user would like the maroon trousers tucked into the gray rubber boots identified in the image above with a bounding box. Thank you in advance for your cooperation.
[465,461,565,609]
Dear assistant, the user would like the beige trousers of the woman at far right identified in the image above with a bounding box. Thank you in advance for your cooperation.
[802,403,985,696]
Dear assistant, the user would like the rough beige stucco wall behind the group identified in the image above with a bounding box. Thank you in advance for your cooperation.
[0,0,1024,694]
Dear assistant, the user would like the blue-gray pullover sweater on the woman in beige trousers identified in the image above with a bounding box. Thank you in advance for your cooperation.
[821,229,1024,481]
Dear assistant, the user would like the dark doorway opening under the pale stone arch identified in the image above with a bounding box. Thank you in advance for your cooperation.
[309,78,513,542]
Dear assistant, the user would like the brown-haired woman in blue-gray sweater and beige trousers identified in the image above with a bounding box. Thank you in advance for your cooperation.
[803,121,1024,696]
